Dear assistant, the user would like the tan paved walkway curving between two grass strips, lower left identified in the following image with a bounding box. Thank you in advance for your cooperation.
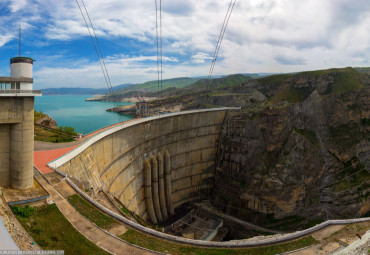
[36,175,155,255]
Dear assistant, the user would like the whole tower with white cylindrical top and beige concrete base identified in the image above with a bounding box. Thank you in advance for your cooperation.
[0,56,41,190]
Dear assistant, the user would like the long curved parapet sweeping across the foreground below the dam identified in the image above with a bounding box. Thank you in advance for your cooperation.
[63,170,370,248]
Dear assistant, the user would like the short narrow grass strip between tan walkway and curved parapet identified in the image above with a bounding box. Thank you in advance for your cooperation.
[67,194,117,230]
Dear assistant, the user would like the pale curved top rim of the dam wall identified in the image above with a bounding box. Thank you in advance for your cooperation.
[47,107,231,169]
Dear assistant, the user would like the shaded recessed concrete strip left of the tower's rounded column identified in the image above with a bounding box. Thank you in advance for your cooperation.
[0,124,10,187]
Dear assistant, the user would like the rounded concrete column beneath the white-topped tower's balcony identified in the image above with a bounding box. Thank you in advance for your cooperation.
[10,97,34,190]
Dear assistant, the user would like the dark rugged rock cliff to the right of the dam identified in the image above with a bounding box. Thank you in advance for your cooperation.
[213,85,370,223]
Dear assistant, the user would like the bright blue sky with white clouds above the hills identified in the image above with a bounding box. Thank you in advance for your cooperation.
[0,0,370,89]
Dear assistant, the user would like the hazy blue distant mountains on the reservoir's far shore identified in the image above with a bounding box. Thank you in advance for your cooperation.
[42,83,132,95]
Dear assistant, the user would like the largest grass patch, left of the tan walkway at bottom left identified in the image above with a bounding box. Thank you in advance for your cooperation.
[16,204,109,255]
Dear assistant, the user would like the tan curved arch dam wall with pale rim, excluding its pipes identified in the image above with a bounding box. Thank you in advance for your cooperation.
[49,108,228,219]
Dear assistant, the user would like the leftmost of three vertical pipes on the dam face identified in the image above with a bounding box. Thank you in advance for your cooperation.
[144,159,158,224]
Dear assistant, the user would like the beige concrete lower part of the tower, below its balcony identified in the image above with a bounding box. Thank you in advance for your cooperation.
[0,97,34,190]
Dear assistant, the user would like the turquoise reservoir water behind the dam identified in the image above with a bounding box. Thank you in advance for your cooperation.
[35,95,132,134]
